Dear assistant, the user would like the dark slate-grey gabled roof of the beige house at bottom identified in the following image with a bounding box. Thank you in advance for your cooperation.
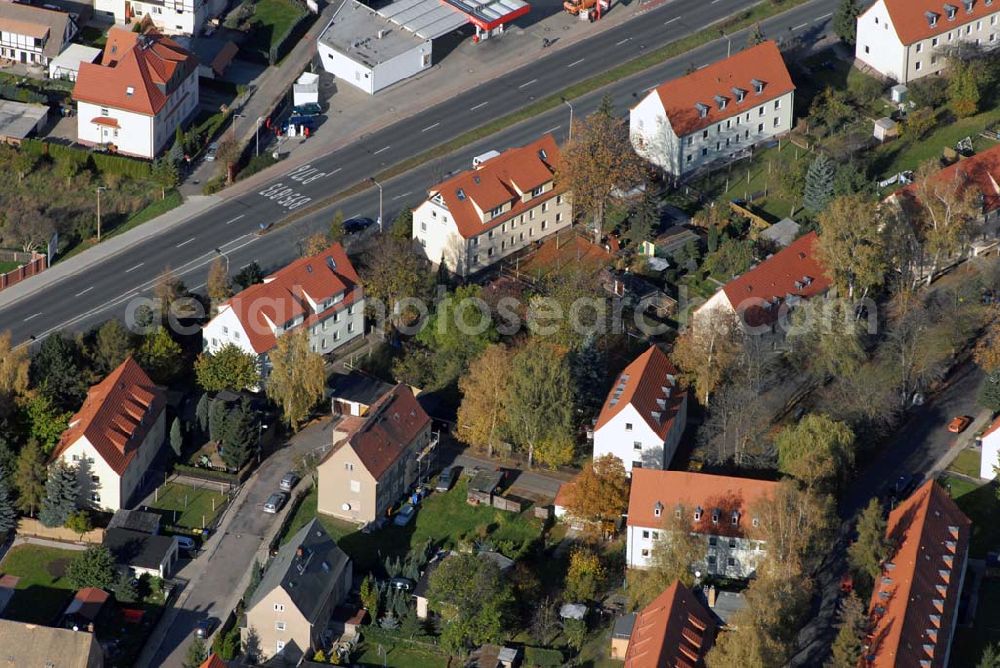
[247,519,350,623]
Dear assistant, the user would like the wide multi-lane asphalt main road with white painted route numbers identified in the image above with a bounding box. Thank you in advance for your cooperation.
[0,0,838,342]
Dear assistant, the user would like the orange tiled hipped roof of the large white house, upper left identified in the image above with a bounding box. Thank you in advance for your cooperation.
[73,27,198,120]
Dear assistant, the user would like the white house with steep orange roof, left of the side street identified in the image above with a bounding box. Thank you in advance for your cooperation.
[51,356,166,511]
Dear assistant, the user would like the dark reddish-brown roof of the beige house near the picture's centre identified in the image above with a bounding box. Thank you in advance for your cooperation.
[327,383,431,480]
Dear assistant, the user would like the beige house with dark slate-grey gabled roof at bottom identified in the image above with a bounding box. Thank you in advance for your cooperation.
[242,519,352,665]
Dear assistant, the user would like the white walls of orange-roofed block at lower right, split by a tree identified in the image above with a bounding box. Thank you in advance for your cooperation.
[626,526,764,579]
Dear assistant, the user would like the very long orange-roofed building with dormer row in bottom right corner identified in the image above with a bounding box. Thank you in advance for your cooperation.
[863,480,972,668]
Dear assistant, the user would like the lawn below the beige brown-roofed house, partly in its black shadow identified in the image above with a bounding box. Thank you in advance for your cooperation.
[283,478,542,574]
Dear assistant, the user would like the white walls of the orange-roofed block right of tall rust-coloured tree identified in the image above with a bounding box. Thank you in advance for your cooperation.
[629,89,795,176]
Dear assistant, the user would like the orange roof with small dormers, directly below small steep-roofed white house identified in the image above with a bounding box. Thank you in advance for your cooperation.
[628,469,778,536]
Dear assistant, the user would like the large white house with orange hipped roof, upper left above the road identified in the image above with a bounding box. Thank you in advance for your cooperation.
[73,27,198,159]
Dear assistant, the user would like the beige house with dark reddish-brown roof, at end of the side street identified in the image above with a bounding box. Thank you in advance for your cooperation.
[317,384,437,523]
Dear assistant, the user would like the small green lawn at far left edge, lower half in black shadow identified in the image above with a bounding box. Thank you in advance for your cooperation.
[0,544,80,625]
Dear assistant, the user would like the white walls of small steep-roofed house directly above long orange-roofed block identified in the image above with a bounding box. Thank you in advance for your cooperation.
[594,396,687,475]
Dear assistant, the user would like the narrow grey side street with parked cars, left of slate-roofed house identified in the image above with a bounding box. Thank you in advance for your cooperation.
[138,420,332,667]
